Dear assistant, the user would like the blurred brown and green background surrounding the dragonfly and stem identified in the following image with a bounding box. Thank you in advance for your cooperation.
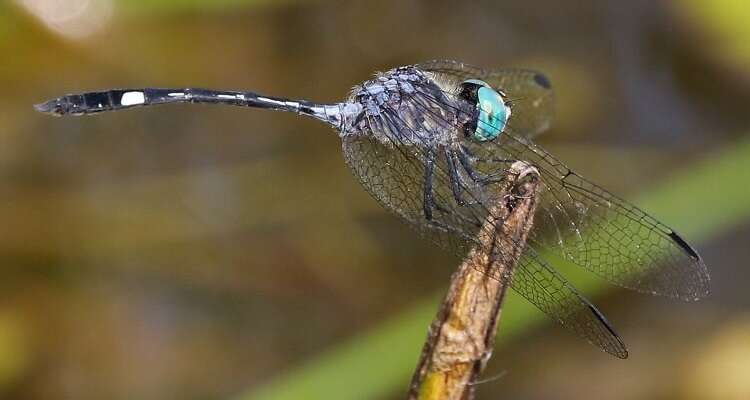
[0,0,750,400]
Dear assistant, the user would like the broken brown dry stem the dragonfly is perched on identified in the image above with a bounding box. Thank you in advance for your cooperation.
[409,161,539,400]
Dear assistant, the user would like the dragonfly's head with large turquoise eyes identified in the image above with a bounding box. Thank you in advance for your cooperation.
[459,79,510,142]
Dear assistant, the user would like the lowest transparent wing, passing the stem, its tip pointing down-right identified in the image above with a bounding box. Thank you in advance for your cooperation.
[343,81,627,358]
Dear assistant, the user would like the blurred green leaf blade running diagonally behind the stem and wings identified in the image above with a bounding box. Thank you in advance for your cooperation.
[238,136,750,400]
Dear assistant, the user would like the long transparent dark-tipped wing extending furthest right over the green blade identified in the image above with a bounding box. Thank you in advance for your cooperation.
[408,80,709,300]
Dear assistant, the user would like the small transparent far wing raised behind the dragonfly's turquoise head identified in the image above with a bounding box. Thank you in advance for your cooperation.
[417,60,555,138]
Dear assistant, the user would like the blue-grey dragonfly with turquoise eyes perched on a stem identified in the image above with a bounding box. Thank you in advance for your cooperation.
[35,60,710,358]
